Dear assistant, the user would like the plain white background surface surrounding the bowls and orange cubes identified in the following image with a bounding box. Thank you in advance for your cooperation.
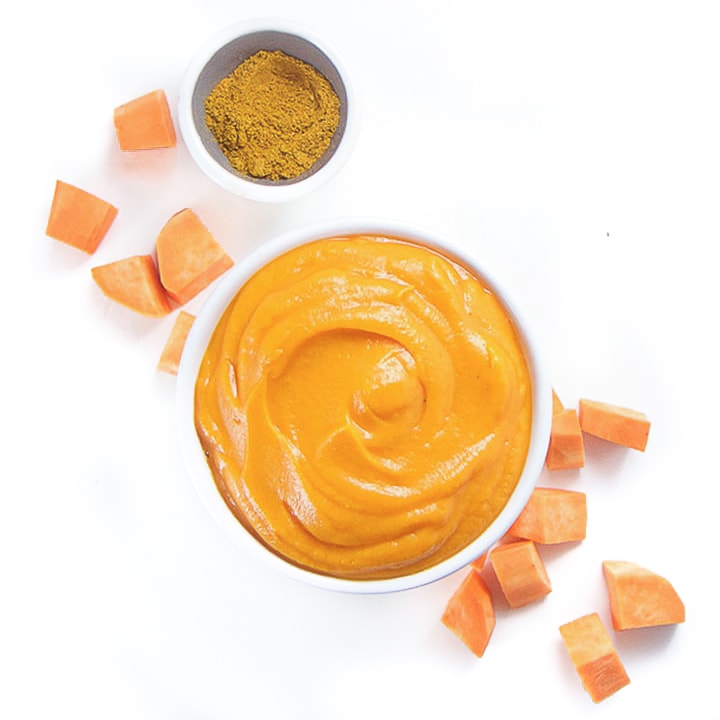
[0,0,720,720]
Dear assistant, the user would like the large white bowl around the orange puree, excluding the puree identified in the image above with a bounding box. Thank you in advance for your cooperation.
[177,220,552,593]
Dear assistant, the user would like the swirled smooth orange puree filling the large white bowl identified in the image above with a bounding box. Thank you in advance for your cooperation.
[195,236,532,579]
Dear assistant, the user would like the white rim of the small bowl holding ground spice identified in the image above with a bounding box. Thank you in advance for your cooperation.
[177,18,360,203]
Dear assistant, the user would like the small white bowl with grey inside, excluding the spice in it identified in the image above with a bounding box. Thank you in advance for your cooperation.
[178,20,358,202]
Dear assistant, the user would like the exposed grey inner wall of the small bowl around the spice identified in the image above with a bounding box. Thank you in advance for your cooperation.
[190,30,348,185]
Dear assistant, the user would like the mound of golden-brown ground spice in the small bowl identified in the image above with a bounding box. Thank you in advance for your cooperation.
[205,50,340,180]
